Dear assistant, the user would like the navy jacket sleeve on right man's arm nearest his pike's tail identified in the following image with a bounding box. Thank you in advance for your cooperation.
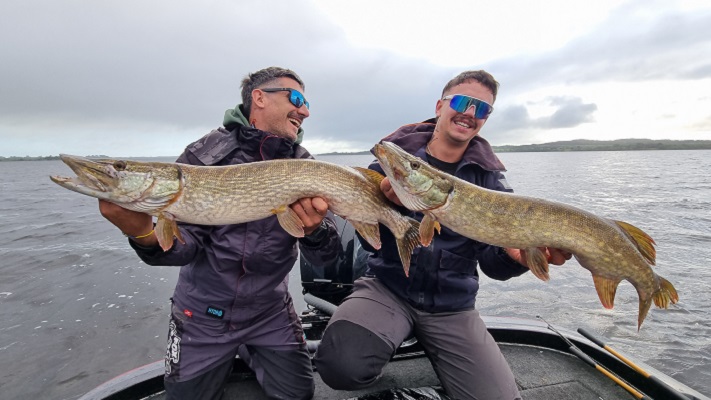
[477,171,529,281]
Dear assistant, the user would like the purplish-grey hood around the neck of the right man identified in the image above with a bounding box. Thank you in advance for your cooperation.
[378,118,506,171]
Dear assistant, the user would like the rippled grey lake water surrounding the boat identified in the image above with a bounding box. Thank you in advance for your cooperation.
[0,151,711,399]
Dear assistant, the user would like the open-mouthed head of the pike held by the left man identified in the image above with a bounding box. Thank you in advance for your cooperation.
[50,154,182,215]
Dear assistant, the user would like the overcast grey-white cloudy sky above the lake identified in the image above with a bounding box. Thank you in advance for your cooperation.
[0,0,711,157]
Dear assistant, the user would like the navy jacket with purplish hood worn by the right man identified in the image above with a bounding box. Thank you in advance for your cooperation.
[368,120,528,312]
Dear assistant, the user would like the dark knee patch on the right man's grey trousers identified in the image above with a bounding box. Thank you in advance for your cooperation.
[314,320,394,390]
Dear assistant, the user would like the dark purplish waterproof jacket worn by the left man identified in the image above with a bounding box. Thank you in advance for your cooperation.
[131,106,340,322]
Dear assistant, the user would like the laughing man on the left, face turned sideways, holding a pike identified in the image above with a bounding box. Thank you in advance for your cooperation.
[99,67,340,399]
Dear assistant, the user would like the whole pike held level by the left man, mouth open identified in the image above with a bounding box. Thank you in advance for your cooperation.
[50,155,419,271]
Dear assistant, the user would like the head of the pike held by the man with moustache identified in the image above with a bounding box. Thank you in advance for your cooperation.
[375,142,454,211]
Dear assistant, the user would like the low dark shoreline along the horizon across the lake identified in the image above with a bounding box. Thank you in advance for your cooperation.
[5,139,711,162]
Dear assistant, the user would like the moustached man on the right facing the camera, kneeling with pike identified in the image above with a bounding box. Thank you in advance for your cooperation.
[314,71,571,400]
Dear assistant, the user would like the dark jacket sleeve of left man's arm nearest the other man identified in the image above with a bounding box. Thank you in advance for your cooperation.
[299,211,341,267]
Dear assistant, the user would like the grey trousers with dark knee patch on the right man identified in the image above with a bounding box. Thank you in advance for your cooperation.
[314,278,521,400]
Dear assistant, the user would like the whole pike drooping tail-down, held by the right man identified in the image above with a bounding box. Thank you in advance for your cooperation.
[375,142,679,329]
